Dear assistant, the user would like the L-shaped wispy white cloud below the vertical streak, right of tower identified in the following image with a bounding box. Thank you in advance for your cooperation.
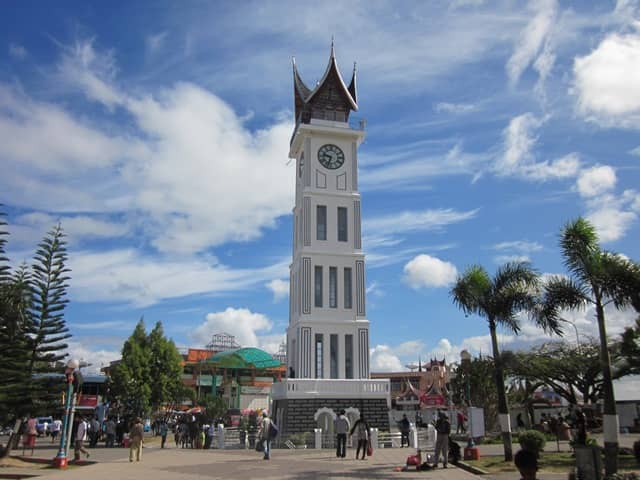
[494,113,580,181]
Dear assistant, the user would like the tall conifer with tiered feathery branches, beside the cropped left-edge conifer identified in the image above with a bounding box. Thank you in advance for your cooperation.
[25,224,71,414]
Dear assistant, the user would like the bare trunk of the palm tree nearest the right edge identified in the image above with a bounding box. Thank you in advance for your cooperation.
[596,296,619,476]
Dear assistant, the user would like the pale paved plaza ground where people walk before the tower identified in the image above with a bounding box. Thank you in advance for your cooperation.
[0,434,640,480]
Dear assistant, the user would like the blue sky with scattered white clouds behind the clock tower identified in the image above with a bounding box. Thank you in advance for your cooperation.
[0,0,640,371]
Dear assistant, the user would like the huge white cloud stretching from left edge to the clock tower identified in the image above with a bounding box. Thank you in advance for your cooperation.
[0,42,294,254]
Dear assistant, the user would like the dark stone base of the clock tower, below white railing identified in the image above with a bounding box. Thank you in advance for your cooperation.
[272,398,389,435]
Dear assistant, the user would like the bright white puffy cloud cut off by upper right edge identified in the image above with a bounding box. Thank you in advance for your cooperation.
[573,33,640,127]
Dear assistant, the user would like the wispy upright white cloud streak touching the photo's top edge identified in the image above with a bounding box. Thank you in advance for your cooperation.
[507,0,557,85]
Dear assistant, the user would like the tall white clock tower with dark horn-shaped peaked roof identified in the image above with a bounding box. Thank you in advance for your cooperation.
[273,45,389,432]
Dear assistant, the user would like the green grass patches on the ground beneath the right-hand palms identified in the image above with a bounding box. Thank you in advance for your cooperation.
[465,452,640,473]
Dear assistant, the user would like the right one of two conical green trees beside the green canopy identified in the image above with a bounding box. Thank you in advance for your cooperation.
[148,322,182,411]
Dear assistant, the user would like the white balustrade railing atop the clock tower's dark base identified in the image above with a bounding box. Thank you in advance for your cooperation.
[271,378,389,400]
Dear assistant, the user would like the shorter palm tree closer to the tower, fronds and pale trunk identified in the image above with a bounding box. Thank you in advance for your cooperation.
[451,262,560,461]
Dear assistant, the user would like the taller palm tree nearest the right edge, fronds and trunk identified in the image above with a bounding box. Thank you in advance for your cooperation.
[538,218,640,475]
